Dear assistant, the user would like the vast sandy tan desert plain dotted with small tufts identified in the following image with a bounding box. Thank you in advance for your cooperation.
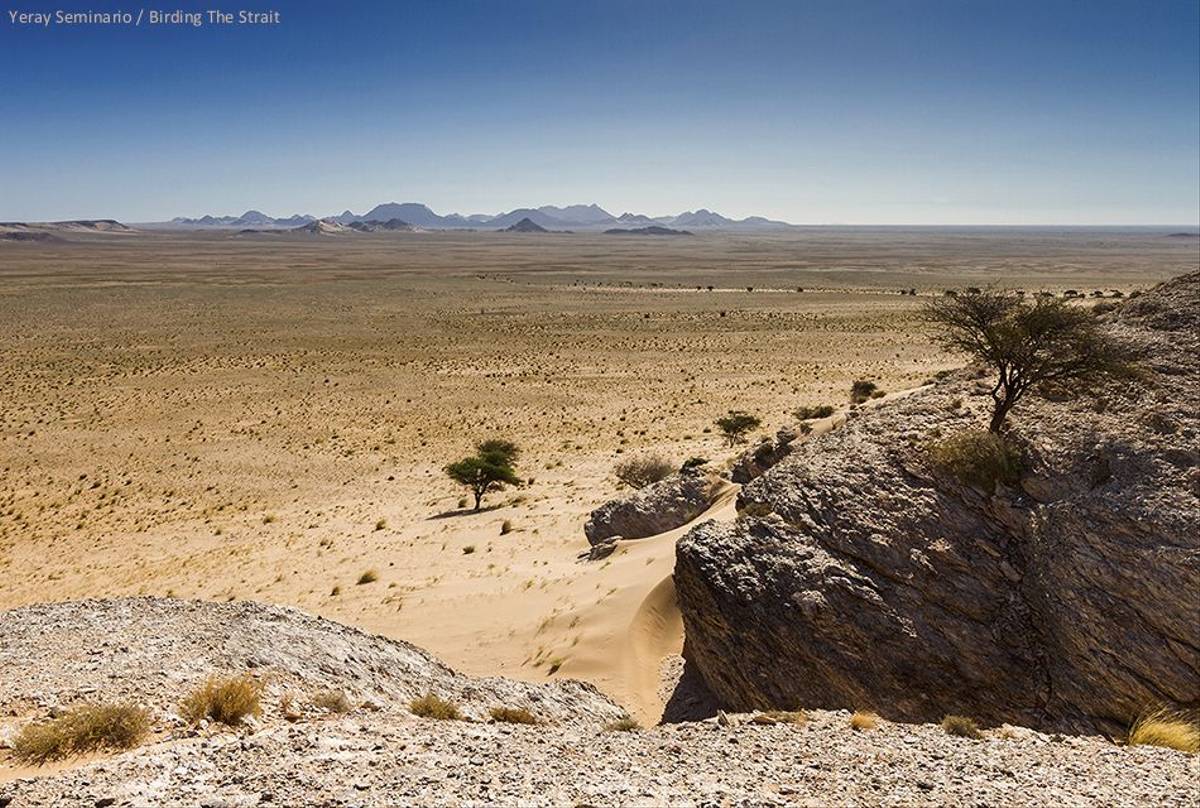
[0,228,1200,723]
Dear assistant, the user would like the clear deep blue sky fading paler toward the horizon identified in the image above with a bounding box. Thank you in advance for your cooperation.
[0,0,1200,226]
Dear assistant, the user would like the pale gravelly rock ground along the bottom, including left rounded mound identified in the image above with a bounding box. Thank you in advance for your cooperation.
[0,598,1200,808]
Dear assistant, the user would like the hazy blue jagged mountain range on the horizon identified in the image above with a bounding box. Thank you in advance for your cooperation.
[155,202,792,232]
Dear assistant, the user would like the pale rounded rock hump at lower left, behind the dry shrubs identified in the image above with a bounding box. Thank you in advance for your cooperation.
[0,598,624,726]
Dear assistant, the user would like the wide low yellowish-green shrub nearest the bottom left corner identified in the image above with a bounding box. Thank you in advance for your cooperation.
[12,704,150,766]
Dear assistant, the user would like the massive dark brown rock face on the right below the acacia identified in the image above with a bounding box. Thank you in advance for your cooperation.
[676,274,1200,731]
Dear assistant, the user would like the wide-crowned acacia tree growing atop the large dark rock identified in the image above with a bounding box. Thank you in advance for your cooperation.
[925,289,1133,433]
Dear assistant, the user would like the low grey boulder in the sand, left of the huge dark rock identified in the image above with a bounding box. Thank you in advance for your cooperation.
[583,468,720,545]
